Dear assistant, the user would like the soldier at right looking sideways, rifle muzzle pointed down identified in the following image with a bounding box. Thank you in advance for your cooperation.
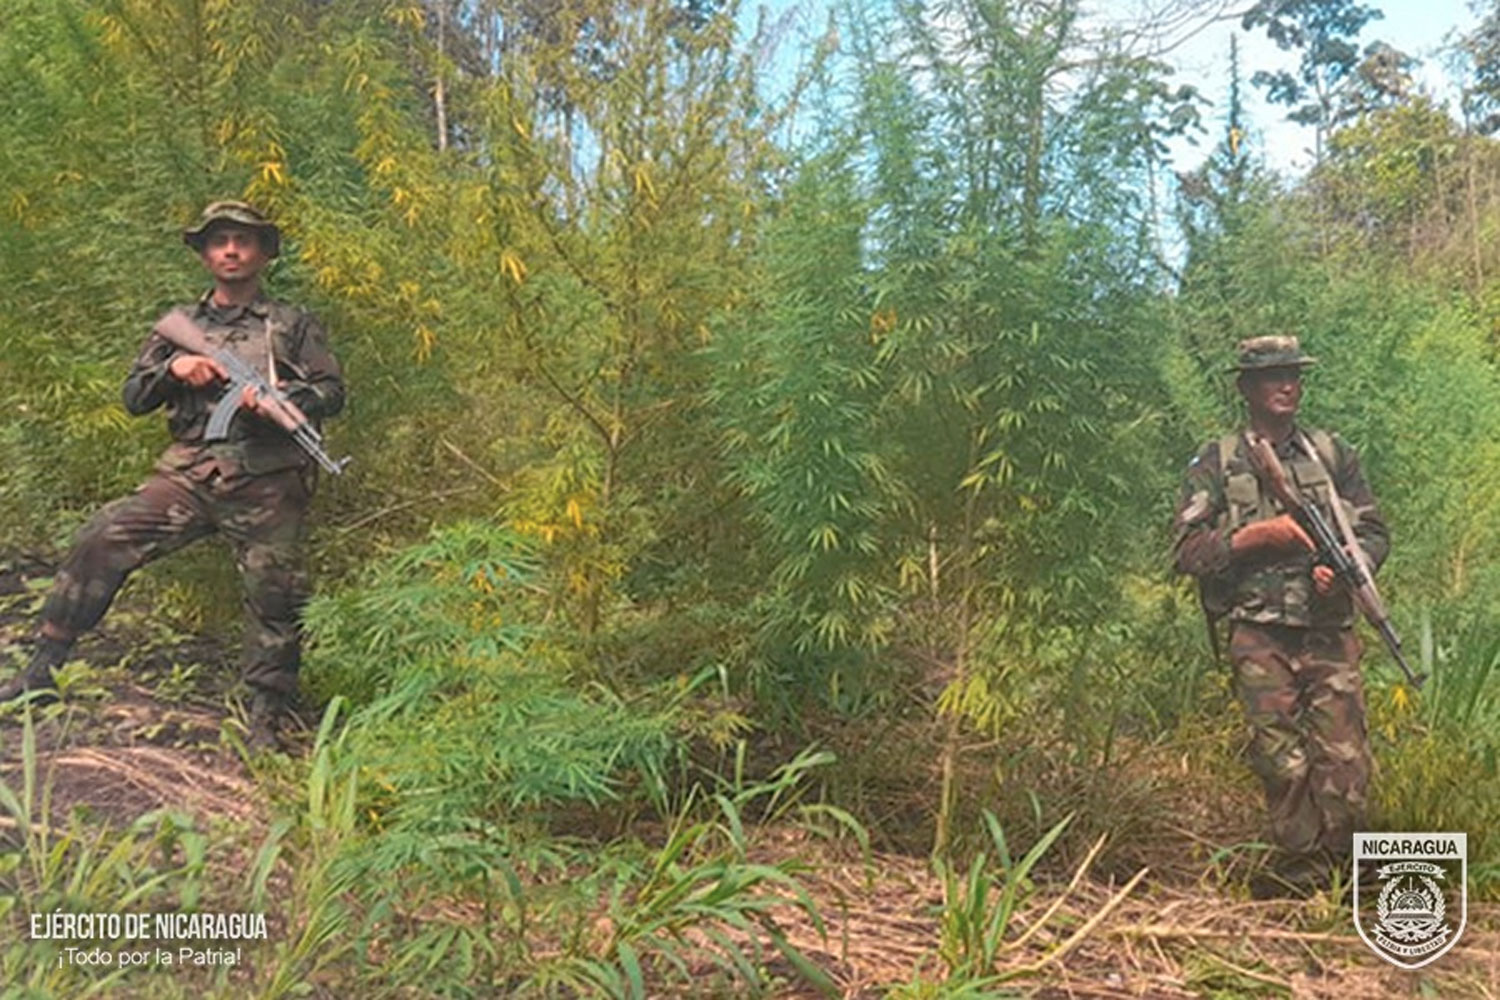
[1175,337,1389,895]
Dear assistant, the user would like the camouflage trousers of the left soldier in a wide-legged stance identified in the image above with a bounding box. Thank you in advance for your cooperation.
[42,469,309,693]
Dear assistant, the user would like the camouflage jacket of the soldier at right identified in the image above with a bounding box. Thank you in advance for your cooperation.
[1173,429,1391,627]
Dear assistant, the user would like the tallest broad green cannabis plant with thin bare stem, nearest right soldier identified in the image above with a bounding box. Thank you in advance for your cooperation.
[720,0,1194,849]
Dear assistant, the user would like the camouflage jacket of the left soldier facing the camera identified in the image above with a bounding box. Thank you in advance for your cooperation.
[125,292,344,477]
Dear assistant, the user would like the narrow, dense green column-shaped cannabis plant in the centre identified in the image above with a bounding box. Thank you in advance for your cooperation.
[711,154,900,708]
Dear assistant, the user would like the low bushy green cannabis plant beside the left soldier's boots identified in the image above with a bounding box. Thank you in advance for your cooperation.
[308,523,674,815]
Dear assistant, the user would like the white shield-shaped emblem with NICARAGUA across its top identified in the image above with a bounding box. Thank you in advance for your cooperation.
[1355,834,1469,969]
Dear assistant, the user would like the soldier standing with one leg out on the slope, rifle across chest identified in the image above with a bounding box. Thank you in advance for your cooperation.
[0,201,344,745]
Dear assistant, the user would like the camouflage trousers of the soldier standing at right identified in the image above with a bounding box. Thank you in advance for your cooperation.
[1229,622,1370,858]
